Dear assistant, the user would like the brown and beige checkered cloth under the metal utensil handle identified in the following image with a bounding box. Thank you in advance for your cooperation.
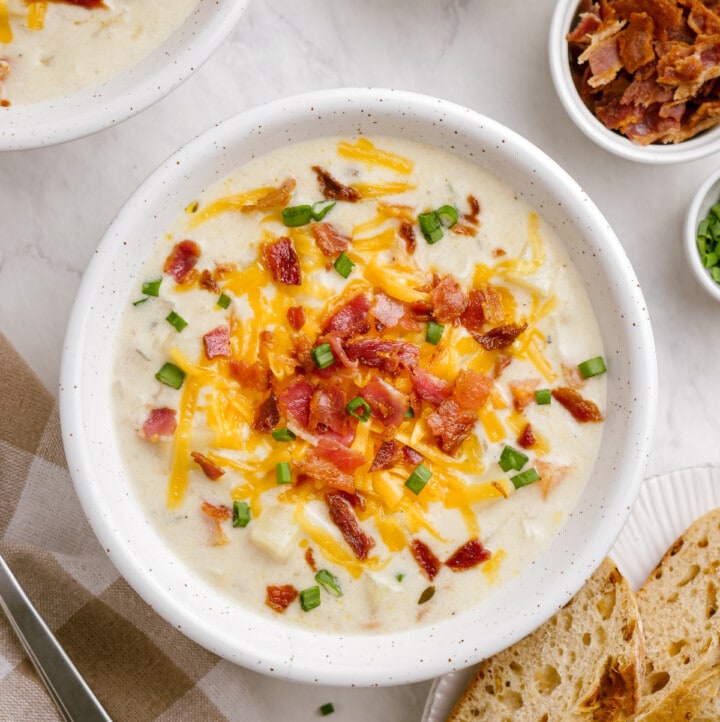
[0,334,266,722]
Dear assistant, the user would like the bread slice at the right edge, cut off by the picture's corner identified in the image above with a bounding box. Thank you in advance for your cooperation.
[637,509,720,722]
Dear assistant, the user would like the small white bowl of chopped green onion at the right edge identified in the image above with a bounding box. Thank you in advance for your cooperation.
[685,170,720,301]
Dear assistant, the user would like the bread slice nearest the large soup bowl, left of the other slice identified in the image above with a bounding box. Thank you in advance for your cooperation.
[448,559,643,722]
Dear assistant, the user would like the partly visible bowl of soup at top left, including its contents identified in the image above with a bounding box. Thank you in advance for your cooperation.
[0,0,247,150]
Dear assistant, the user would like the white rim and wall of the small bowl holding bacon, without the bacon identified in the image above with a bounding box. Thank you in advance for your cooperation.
[548,0,720,165]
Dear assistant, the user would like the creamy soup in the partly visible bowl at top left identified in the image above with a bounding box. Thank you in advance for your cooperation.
[0,0,199,106]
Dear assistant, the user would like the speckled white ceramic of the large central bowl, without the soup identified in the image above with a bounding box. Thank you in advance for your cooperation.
[60,89,656,685]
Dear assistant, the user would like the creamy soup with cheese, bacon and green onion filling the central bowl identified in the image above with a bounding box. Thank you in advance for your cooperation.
[114,137,606,633]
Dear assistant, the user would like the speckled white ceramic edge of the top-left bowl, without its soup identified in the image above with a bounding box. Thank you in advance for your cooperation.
[0,0,248,151]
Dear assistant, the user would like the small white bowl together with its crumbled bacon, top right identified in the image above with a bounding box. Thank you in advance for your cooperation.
[549,0,720,164]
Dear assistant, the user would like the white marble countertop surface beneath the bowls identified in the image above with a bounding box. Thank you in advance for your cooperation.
[0,0,720,720]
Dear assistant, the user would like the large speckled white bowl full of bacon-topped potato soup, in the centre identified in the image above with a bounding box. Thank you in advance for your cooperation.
[60,89,656,685]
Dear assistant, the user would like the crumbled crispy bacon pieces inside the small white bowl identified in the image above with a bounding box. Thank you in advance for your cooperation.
[567,0,720,145]
